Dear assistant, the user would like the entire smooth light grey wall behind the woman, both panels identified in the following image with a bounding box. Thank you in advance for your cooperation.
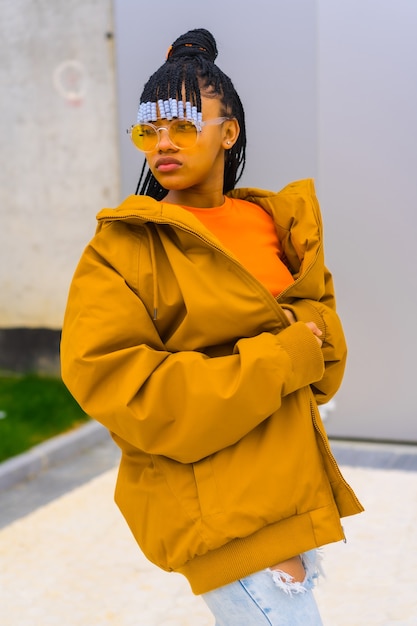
[115,0,417,441]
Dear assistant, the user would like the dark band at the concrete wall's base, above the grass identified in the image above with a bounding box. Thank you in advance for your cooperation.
[0,328,61,376]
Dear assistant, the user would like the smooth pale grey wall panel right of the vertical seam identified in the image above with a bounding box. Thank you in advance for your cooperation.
[318,0,417,441]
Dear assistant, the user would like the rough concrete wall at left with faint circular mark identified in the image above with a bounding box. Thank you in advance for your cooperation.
[0,0,120,329]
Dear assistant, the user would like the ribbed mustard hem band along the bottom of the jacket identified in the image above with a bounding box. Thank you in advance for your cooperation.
[177,505,344,595]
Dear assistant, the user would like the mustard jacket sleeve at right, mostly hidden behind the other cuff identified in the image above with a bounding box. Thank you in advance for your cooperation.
[284,267,347,404]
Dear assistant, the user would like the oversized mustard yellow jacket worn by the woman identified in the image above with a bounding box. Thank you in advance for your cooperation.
[61,180,362,593]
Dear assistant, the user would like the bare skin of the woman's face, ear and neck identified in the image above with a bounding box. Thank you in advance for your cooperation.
[146,96,239,206]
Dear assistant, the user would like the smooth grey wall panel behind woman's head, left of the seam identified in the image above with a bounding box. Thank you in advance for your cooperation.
[114,0,317,195]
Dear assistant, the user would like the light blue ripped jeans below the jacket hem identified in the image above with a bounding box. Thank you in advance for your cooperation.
[202,550,323,626]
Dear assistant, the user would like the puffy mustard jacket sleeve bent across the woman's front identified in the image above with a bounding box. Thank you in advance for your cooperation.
[61,232,324,463]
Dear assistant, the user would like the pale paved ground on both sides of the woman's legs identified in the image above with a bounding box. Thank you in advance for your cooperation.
[0,428,417,626]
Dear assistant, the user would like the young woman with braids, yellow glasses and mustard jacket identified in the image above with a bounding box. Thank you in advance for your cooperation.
[62,29,362,626]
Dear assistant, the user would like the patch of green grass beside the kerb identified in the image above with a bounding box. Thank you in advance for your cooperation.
[0,374,89,462]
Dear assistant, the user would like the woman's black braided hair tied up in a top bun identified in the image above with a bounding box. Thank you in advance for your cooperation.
[136,28,246,200]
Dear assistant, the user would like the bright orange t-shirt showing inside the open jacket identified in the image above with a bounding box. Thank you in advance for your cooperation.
[183,197,294,296]
